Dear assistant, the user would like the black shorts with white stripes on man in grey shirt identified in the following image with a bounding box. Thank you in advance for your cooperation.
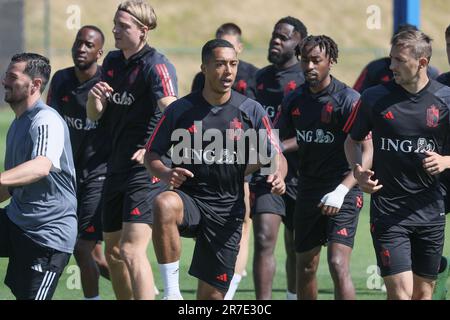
[0,209,70,300]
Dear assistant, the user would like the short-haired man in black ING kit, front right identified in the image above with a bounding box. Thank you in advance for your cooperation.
[346,30,450,299]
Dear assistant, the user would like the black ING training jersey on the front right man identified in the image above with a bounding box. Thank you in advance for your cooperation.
[347,80,450,226]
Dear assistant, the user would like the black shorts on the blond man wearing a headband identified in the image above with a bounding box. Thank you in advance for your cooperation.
[102,167,168,232]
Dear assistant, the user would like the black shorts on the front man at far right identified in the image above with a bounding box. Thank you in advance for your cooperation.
[370,223,445,280]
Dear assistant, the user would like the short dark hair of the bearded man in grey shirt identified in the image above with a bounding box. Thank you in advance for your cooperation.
[11,52,52,93]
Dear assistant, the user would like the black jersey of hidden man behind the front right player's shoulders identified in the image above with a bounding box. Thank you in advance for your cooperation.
[353,57,439,93]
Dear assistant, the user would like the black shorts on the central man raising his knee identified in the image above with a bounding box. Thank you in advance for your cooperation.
[175,190,243,292]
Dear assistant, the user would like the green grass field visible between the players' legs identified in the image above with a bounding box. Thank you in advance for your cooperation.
[0,109,450,300]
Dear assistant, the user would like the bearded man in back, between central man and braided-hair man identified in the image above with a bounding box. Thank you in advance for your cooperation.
[250,17,307,300]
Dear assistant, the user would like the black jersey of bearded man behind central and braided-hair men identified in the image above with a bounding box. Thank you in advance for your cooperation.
[252,63,305,194]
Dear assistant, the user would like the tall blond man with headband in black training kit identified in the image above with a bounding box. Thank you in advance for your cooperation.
[87,0,177,299]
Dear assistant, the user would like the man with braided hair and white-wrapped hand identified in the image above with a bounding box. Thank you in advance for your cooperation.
[275,35,371,300]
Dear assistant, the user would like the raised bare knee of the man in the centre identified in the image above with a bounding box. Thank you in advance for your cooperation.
[153,192,183,225]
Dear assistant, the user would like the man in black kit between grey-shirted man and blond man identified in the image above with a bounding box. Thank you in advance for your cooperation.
[47,26,111,300]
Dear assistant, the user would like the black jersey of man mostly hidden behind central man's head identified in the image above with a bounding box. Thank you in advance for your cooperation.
[191,60,258,99]
